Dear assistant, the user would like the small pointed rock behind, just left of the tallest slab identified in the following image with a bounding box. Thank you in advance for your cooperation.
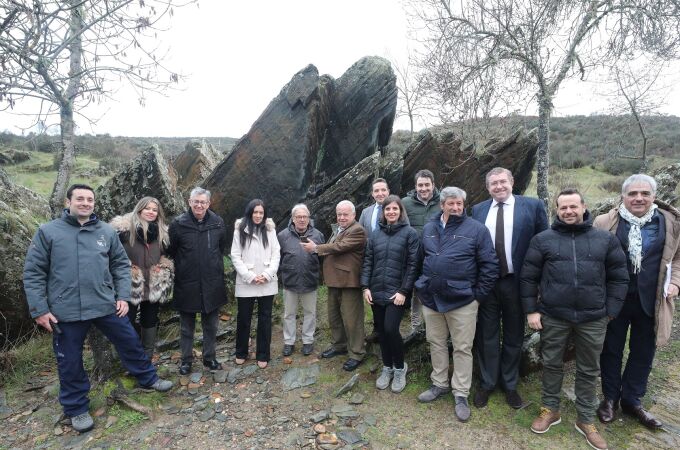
[172,140,222,198]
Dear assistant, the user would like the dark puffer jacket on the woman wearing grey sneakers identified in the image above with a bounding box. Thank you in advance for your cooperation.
[361,222,420,305]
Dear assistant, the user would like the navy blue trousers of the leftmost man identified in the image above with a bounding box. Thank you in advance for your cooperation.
[52,314,158,417]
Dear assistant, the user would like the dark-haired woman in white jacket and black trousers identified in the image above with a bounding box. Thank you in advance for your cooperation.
[231,199,281,369]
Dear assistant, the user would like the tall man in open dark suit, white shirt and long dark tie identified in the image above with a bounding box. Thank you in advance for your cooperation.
[472,167,548,409]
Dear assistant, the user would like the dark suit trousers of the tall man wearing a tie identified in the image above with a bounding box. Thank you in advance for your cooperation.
[474,275,525,391]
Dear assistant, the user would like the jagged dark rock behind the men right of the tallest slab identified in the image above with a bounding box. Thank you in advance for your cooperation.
[401,129,538,205]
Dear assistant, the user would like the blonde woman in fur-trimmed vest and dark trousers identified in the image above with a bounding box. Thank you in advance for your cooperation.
[111,197,174,359]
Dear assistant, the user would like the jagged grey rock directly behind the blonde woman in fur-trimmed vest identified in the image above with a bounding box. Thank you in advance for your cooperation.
[95,145,186,221]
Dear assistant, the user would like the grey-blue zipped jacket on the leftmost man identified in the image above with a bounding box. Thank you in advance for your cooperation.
[24,211,130,322]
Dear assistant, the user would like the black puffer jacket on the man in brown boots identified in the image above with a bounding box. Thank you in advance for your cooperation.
[520,211,628,323]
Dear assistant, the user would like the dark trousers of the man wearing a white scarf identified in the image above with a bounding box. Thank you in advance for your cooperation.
[600,293,656,406]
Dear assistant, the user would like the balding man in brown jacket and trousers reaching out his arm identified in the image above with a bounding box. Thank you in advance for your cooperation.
[300,200,366,371]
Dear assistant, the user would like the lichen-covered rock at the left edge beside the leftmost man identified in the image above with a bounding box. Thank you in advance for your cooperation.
[0,169,50,348]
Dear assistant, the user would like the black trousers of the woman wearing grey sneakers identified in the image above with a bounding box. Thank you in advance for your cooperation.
[371,303,405,369]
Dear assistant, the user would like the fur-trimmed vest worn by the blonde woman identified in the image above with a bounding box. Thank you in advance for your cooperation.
[110,213,175,305]
